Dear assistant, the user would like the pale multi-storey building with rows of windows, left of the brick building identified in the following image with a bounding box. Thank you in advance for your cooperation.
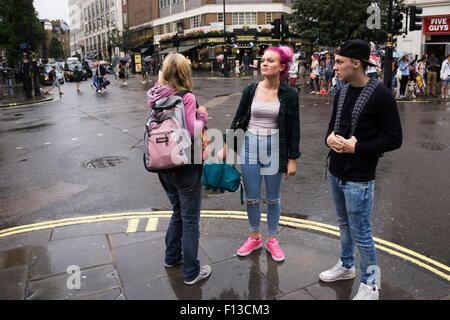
[81,0,123,59]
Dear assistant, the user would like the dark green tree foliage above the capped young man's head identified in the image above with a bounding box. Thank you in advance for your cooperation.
[288,0,401,46]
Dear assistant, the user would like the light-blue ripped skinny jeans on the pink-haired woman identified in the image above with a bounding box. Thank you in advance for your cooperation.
[241,131,284,237]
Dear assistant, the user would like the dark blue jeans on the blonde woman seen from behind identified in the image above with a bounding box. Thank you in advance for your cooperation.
[158,165,202,281]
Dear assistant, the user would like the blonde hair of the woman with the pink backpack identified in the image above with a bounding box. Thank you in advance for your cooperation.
[160,53,192,91]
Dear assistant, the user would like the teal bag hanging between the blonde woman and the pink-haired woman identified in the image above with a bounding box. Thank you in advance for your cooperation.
[202,161,244,204]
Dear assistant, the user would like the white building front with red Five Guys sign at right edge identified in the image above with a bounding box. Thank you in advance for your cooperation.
[397,0,450,61]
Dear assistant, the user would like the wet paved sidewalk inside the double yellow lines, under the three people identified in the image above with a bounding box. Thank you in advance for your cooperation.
[0,214,449,300]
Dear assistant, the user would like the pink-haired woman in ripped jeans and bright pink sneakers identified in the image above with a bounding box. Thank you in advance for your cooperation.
[218,46,300,261]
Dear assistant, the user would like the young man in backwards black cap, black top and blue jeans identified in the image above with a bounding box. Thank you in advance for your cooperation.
[319,40,402,300]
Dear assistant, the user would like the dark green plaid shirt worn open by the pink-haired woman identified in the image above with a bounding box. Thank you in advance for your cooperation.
[230,82,301,172]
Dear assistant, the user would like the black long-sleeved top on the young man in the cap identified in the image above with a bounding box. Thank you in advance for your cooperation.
[325,84,402,182]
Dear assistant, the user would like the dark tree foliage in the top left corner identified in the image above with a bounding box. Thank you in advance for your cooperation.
[0,0,45,66]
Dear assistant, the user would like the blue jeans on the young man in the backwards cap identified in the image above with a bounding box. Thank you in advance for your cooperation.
[330,173,377,284]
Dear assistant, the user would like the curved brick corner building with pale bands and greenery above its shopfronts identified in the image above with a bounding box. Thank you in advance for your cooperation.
[122,0,299,68]
